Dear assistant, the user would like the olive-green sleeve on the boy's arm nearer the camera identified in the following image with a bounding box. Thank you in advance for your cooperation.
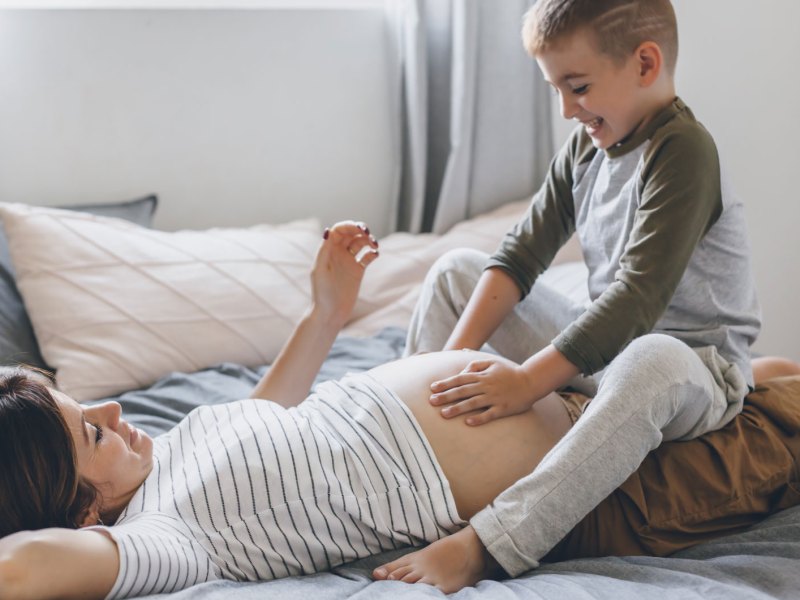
[553,126,722,374]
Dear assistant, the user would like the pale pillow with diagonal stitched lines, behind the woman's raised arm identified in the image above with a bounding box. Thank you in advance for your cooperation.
[0,204,320,401]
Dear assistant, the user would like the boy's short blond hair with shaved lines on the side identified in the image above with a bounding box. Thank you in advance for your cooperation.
[522,0,678,75]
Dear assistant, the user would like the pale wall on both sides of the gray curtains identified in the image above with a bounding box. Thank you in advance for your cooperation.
[0,5,800,360]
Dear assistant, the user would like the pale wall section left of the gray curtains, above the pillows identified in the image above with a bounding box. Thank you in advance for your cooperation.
[0,7,399,233]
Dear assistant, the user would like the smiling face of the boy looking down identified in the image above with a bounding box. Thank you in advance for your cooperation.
[536,30,649,150]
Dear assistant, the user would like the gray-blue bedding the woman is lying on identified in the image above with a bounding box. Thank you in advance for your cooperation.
[98,329,800,600]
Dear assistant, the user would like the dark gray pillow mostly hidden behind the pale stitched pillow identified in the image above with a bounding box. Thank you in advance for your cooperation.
[0,195,158,369]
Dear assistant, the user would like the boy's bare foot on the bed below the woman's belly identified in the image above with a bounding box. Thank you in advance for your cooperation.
[372,526,501,594]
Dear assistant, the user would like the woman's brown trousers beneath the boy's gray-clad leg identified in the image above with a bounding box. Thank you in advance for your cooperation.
[545,376,800,562]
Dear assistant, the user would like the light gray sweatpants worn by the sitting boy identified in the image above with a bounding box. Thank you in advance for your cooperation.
[406,250,748,576]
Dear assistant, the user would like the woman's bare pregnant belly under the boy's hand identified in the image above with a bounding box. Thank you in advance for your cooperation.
[370,350,570,520]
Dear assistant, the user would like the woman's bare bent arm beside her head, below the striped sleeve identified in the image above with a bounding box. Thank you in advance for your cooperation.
[0,529,119,600]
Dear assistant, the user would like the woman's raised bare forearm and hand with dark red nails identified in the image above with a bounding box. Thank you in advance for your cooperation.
[251,221,378,408]
